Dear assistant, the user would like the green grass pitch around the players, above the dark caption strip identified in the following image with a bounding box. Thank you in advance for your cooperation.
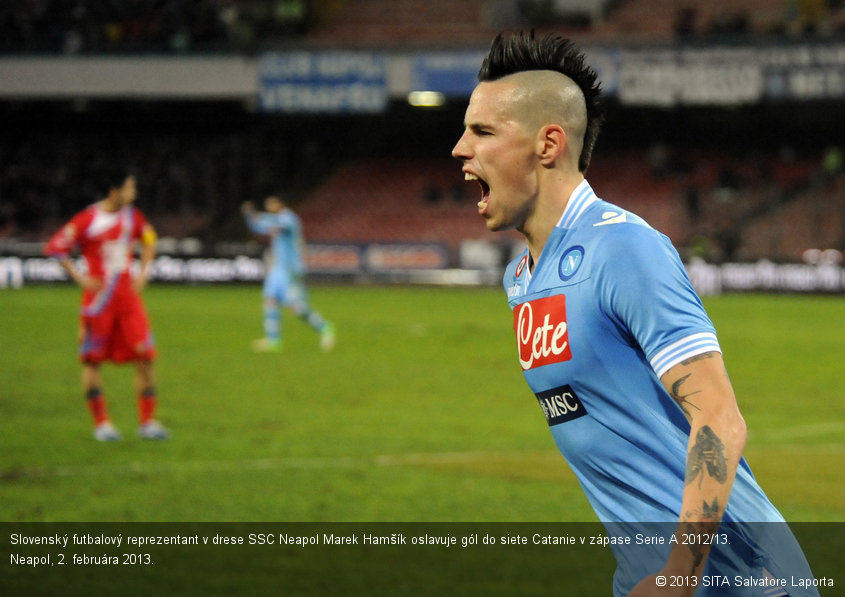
[0,284,845,522]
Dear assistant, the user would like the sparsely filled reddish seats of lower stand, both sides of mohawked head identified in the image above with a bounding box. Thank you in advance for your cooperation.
[290,146,845,260]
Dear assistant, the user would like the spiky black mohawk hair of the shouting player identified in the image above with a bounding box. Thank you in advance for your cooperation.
[478,29,605,173]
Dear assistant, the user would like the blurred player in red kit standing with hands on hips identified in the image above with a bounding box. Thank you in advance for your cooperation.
[45,169,168,441]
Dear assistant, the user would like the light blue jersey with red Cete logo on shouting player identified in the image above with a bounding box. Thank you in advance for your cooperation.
[503,181,812,595]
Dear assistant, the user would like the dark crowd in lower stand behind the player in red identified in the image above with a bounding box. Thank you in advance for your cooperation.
[0,118,295,241]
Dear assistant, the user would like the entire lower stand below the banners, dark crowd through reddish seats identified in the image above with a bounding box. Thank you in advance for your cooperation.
[0,105,845,260]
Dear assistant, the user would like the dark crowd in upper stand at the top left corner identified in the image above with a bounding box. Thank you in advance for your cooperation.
[0,0,308,54]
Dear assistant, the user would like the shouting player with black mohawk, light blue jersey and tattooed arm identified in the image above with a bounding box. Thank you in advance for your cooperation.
[452,32,817,597]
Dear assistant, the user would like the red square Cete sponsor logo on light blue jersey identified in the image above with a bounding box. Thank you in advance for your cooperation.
[513,294,572,371]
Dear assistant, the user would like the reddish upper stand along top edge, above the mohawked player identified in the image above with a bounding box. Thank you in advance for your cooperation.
[308,0,845,46]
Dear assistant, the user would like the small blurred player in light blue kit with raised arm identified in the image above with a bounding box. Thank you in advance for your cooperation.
[241,196,335,352]
